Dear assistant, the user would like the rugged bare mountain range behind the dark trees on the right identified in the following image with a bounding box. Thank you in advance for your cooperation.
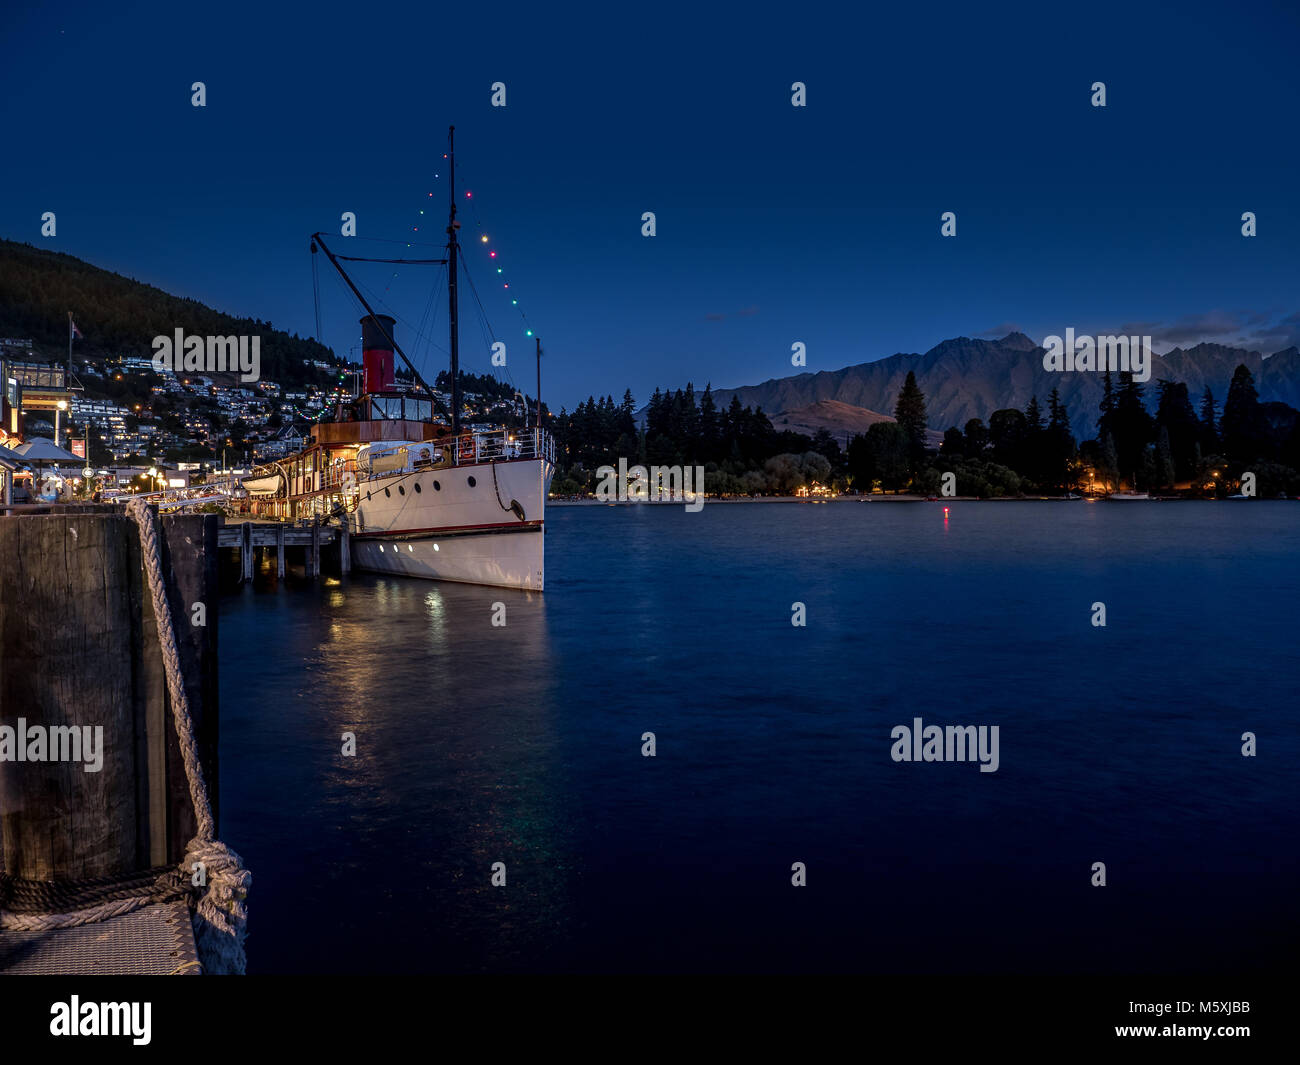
[714,333,1300,440]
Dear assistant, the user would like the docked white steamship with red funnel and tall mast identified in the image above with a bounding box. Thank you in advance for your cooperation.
[243,127,555,592]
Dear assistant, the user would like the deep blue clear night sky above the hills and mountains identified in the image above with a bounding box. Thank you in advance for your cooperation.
[0,3,1300,408]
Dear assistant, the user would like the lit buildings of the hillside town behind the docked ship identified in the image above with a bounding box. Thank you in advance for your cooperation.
[0,338,524,502]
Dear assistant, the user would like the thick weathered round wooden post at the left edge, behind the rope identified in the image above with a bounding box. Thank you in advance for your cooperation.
[0,514,150,880]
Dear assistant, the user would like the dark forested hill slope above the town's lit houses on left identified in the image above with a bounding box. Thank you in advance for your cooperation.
[0,239,337,388]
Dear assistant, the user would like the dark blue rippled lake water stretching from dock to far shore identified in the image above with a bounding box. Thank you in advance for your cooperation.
[220,501,1300,973]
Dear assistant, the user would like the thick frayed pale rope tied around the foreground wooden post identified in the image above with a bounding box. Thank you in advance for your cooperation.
[0,499,252,974]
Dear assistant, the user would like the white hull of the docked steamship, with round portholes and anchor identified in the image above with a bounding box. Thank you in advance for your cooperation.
[348,458,555,592]
